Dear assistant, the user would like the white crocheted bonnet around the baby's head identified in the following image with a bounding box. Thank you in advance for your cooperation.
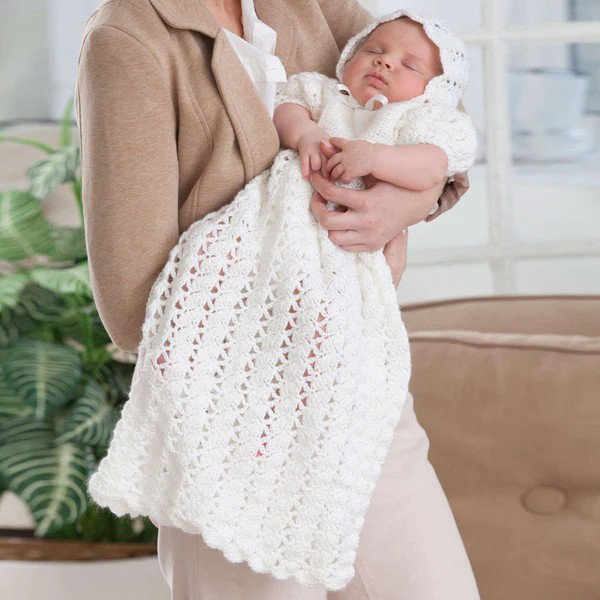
[336,9,469,107]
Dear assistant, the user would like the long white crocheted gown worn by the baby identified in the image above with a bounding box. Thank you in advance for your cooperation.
[89,12,472,590]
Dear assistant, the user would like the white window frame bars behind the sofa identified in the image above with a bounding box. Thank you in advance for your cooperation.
[365,0,600,294]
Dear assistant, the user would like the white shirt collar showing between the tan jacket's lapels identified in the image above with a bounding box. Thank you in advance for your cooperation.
[224,0,287,118]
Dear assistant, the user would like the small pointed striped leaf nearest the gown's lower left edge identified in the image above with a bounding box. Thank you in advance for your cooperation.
[58,380,119,446]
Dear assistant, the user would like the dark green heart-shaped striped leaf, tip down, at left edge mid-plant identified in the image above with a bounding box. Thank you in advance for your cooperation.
[3,338,82,420]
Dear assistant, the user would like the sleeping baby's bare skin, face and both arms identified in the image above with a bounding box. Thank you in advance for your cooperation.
[274,16,448,190]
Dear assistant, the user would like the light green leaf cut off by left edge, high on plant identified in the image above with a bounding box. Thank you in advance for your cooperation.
[0,190,54,260]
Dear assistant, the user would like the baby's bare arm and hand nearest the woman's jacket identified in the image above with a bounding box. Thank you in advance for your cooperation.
[273,102,328,179]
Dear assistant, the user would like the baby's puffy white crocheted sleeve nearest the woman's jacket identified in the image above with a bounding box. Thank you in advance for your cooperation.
[275,72,339,121]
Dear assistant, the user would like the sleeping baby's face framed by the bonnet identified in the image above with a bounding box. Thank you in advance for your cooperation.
[343,18,442,104]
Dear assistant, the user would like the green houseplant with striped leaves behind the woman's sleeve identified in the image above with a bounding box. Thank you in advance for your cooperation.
[0,100,157,543]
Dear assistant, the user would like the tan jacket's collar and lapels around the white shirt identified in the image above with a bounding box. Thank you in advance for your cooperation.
[150,0,284,181]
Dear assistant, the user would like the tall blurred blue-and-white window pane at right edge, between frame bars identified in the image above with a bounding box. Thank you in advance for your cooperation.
[509,44,600,248]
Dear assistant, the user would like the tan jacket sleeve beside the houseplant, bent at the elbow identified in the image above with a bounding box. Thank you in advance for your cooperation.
[75,25,179,352]
